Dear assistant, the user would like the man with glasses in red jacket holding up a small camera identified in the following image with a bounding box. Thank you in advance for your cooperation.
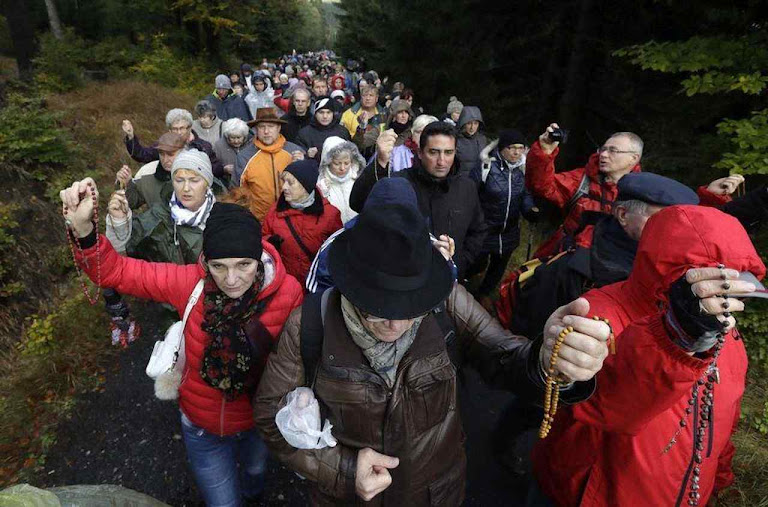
[525,123,643,257]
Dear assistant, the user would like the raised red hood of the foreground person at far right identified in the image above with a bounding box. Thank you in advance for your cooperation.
[625,206,765,310]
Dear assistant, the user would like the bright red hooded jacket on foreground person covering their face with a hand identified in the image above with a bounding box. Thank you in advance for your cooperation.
[533,206,765,506]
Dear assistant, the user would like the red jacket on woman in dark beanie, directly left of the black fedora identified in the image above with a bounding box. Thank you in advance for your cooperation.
[261,193,342,283]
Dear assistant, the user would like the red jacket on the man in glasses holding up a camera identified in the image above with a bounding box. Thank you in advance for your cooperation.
[525,141,640,257]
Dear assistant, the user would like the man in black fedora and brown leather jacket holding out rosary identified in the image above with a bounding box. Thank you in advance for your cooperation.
[254,200,610,506]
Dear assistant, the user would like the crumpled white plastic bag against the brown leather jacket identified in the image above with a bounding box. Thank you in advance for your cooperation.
[275,387,336,449]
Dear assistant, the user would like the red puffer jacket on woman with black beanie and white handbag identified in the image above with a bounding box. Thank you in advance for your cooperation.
[80,235,304,435]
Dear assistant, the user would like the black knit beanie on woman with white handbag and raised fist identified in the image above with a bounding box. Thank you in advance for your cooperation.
[203,202,262,260]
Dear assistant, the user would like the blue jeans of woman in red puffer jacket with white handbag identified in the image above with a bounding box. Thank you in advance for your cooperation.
[181,413,268,507]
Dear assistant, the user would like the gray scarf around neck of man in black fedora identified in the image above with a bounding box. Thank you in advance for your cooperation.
[341,296,424,387]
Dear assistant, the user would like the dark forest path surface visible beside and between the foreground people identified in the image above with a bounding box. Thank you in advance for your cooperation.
[30,303,524,506]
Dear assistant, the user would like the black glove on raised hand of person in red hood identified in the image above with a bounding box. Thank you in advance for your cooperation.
[665,275,726,353]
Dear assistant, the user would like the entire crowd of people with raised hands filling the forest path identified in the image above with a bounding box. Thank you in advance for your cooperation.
[55,48,768,506]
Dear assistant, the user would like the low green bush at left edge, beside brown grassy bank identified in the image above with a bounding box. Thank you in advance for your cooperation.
[0,93,74,173]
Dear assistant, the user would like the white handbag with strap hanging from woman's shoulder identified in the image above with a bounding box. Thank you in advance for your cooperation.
[146,279,205,400]
